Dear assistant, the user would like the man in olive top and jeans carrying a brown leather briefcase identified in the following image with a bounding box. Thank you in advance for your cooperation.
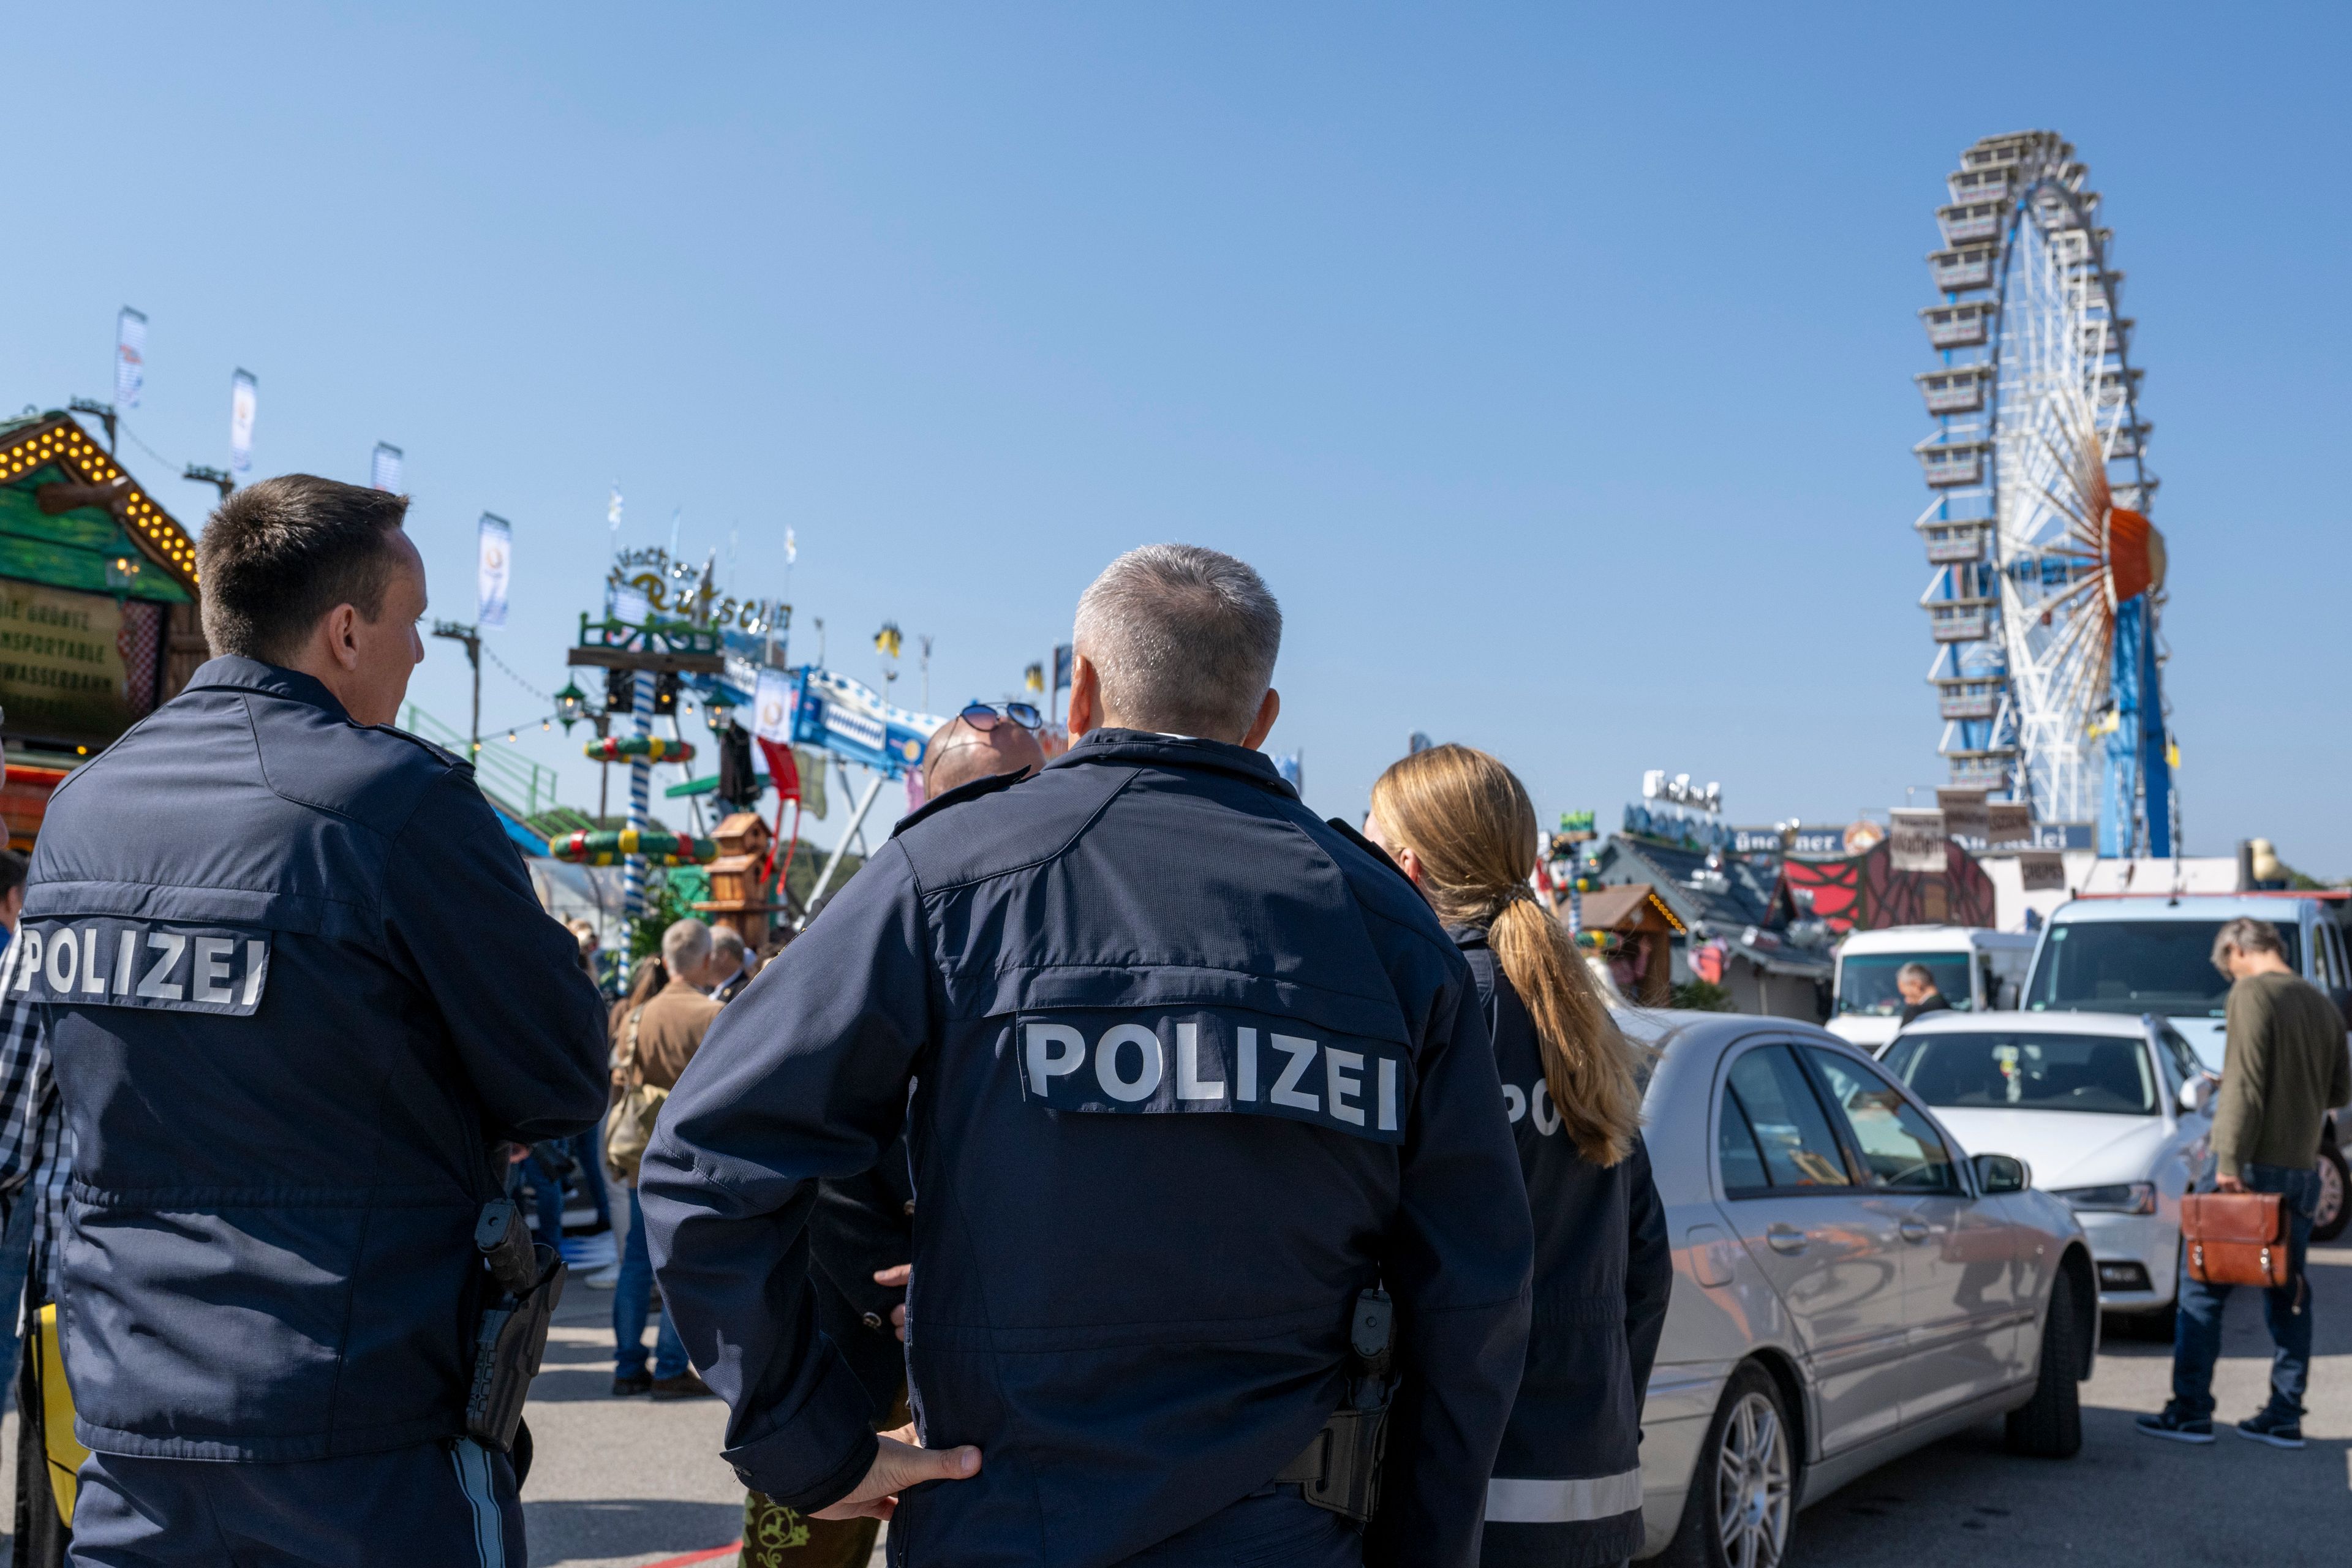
[2138,919,2352,1448]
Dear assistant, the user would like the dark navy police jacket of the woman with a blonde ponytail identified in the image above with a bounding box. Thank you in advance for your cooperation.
[1451,926,1675,1568]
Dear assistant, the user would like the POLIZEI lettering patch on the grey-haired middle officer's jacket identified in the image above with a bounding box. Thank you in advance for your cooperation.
[1011,1009,1414,1142]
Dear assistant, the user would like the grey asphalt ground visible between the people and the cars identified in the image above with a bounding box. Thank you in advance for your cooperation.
[0,1246,2352,1568]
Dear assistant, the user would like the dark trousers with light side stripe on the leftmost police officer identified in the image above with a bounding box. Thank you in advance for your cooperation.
[68,1439,529,1568]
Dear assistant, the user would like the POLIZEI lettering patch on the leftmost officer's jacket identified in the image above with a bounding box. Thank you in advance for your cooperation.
[0,919,271,1018]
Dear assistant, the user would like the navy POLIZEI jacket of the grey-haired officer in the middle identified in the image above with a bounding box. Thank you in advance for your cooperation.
[638,731,1531,1568]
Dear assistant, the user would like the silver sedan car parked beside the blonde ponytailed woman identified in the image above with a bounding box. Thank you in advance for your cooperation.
[1621,1011,2098,1568]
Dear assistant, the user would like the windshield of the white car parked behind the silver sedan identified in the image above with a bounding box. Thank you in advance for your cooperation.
[1887,1030,2157,1117]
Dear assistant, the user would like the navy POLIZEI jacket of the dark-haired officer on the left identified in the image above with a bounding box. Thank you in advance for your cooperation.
[18,658,607,1460]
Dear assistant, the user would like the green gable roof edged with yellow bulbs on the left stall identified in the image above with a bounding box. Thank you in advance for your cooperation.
[0,409,195,604]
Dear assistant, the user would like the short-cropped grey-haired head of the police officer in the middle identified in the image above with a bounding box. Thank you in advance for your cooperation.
[1072,545,1282,741]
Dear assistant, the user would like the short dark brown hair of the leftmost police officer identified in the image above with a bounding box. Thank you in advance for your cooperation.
[195,484,409,665]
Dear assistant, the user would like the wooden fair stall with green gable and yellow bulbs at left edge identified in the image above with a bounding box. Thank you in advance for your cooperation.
[0,412,205,849]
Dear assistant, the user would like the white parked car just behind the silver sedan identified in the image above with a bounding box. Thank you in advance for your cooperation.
[1879,1013,2213,1340]
